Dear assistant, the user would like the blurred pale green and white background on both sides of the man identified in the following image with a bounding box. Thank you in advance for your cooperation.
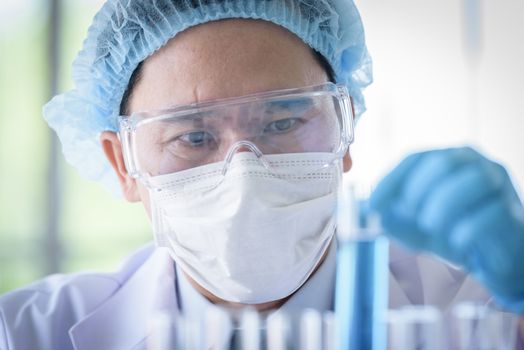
[0,0,524,293]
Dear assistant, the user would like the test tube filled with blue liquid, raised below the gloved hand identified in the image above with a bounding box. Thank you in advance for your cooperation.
[335,186,389,350]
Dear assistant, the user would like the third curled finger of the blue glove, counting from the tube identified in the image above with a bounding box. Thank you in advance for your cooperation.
[418,161,507,239]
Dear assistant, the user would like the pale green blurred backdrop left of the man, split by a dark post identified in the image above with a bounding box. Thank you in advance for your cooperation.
[0,0,152,293]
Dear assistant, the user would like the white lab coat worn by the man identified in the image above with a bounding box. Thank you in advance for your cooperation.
[0,245,508,350]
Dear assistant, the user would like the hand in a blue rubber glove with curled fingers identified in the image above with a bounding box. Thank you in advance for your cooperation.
[370,148,524,314]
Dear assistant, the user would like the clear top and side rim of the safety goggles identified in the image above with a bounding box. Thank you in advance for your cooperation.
[118,82,355,179]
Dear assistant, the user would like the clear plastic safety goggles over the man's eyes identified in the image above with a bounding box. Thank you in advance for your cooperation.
[119,83,353,178]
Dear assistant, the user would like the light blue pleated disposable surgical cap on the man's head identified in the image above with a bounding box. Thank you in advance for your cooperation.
[44,0,372,193]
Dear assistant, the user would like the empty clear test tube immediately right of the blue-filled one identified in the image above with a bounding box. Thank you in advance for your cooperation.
[387,305,447,350]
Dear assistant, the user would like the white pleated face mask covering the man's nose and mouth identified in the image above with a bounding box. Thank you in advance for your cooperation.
[149,152,342,304]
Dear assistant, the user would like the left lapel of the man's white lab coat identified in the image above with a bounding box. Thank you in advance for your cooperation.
[69,248,178,350]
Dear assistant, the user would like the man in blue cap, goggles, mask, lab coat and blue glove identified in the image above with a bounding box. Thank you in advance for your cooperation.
[0,0,524,349]
